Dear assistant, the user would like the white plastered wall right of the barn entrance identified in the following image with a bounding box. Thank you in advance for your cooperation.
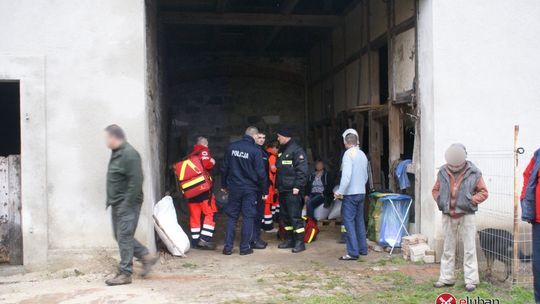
[418,0,540,249]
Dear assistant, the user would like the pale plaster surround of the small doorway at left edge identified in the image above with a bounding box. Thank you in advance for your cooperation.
[0,56,49,269]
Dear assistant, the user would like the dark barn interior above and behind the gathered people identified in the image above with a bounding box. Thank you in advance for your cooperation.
[147,0,420,223]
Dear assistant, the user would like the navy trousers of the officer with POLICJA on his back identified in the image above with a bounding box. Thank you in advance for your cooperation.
[223,189,257,251]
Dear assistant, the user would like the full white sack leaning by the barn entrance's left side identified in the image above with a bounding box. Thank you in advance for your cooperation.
[153,196,190,257]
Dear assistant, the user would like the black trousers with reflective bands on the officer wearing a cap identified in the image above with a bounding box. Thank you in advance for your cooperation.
[279,192,305,240]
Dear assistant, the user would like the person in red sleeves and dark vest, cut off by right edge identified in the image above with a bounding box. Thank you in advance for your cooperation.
[521,149,540,303]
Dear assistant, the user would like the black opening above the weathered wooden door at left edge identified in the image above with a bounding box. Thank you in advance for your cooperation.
[0,81,21,156]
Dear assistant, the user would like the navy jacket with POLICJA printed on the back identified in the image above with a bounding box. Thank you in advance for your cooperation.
[221,135,268,195]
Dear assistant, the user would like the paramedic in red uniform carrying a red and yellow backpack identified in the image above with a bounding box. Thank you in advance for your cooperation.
[188,136,217,250]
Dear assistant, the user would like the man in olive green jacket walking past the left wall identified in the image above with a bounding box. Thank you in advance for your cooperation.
[105,125,157,286]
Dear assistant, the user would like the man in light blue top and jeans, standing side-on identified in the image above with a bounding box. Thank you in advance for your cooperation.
[334,130,368,261]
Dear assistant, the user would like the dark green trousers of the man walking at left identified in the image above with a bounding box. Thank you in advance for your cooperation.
[111,203,148,275]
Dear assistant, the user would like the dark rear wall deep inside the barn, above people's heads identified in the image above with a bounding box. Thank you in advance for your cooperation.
[168,57,305,165]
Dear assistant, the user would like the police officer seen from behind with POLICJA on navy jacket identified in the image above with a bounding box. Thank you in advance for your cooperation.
[221,127,268,255]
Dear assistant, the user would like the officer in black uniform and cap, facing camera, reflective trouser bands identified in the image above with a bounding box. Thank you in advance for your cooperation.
[276,128,308,253]
